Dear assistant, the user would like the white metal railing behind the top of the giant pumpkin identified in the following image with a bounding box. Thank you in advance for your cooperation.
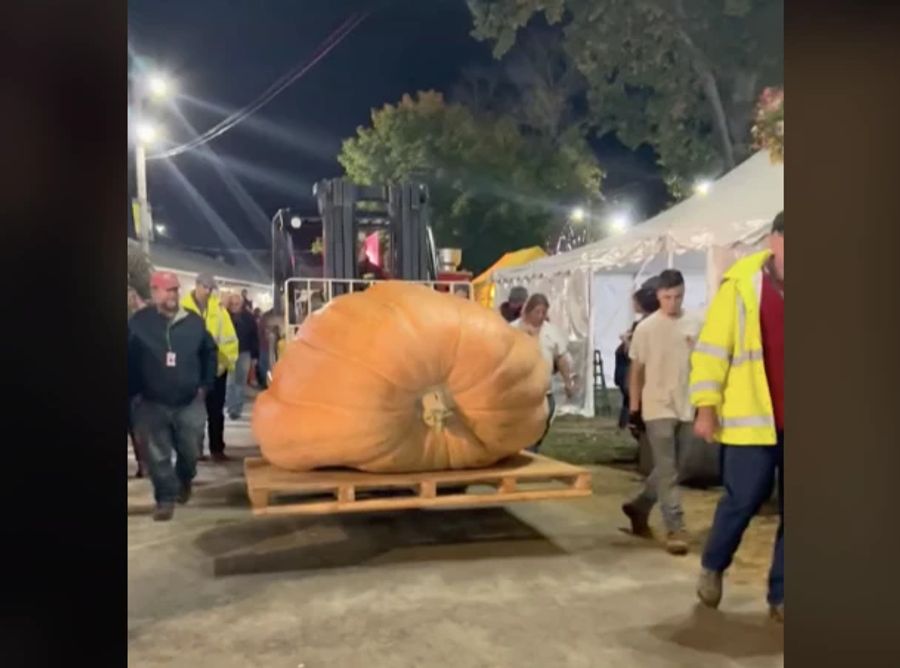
[284,278,475,341]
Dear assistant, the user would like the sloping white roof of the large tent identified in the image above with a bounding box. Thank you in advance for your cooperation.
[496,151,784,282]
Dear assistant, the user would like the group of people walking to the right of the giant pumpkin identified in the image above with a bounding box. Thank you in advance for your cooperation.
[500,212,784,621]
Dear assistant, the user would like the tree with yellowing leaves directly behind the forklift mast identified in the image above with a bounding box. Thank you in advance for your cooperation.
[338,91,602,271]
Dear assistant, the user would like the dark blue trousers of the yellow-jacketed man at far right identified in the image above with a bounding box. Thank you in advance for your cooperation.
[703,431,784,605]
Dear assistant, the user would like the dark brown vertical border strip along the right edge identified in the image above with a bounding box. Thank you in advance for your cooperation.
[785,0,900,668]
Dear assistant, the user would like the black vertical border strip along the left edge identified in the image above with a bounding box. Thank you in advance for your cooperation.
[0,0,128,668]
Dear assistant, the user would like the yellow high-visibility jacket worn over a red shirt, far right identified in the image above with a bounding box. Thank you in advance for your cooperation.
[691,251,777,445]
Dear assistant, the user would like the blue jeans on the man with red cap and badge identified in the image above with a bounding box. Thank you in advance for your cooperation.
[134,398,206,504]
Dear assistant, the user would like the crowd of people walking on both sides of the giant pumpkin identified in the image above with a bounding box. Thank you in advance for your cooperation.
[128,213,784,621]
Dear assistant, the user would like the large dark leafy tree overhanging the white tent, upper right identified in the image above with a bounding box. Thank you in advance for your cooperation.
[468,0,784,194]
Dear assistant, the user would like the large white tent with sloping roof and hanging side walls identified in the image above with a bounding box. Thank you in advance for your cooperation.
[494,151,784,415]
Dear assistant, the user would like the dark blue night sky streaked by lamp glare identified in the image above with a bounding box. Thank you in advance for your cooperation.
[128,0,665,264]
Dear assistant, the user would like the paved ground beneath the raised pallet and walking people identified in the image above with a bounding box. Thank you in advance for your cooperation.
[128,410,784,668]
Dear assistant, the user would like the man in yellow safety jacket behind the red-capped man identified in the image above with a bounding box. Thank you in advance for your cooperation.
[181,274,238,462]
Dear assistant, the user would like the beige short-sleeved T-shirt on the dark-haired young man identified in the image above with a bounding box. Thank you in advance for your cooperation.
[628,311,703,422]
